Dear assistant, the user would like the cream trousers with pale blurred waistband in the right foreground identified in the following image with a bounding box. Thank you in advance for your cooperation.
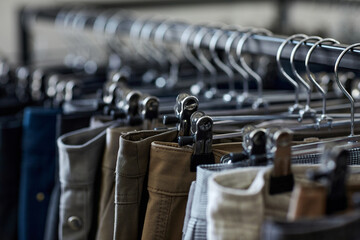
[207,165,360,240]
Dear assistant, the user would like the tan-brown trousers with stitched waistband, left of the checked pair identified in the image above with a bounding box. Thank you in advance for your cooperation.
[142,142,242,240]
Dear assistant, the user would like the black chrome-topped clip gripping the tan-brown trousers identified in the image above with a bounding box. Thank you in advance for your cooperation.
[178,111,215,172]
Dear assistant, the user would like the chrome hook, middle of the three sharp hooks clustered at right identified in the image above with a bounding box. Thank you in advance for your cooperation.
[290,36,322,121]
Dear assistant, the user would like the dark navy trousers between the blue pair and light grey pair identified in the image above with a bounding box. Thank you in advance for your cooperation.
[44,113,92,240]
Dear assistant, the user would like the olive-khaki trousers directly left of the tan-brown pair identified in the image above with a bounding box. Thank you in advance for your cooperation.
[114,130,177,240]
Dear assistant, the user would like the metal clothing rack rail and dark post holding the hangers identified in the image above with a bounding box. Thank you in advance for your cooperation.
[20,0,360,71]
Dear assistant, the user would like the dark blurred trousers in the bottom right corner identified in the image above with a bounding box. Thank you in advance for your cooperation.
[261,211,360,240]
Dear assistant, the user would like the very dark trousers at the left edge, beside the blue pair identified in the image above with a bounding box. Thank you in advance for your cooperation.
[0,117,22,240]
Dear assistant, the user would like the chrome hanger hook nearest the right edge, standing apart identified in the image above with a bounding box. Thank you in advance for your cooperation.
[334,43,360,137]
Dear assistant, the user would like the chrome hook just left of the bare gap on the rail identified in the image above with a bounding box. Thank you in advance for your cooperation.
[236,29,272,109]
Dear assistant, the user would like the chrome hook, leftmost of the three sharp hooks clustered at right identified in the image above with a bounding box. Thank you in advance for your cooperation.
[276,34,308,114]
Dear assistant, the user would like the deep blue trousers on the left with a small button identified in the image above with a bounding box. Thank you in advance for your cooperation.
[18,107,59,240]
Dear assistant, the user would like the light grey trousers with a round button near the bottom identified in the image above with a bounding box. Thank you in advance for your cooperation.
[58,123,120,239]
